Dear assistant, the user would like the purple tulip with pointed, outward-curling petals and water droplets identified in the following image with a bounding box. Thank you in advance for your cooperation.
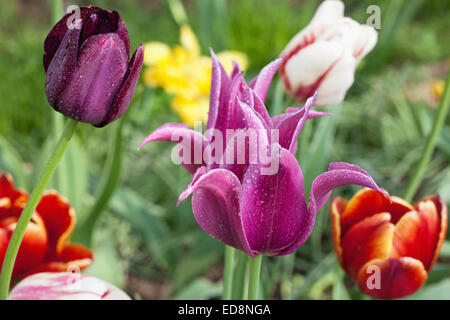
[141,53,383,257]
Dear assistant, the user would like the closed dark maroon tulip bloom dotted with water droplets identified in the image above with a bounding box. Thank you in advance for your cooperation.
[44,7,144,127]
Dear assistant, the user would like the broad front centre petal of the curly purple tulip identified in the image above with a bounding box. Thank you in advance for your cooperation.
[242,148,310,255]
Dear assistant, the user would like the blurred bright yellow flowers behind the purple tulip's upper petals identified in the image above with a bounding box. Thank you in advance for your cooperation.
[144,25,248,126]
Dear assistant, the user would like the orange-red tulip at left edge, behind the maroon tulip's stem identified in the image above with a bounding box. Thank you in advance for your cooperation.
[0,174,93,279]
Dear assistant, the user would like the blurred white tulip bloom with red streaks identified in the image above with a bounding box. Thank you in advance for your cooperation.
[280,0,377,105]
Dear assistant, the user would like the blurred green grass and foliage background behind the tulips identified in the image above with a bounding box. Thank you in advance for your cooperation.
[0,0,450,299]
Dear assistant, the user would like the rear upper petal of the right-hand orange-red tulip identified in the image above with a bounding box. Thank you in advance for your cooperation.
[340,189,414,234]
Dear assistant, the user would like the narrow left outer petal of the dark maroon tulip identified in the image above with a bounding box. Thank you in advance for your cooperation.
[45,23,81,111]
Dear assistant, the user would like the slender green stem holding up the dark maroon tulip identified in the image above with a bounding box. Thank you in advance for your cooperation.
[0,119,78,300]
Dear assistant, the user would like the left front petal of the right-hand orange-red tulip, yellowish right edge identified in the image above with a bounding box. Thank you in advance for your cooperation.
[341,212,394,279]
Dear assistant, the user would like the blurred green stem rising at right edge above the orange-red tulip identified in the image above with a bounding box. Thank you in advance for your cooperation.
[404,71,450,202]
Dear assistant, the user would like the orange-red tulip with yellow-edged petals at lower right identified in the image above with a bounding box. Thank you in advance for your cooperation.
[330,189,448,299]
